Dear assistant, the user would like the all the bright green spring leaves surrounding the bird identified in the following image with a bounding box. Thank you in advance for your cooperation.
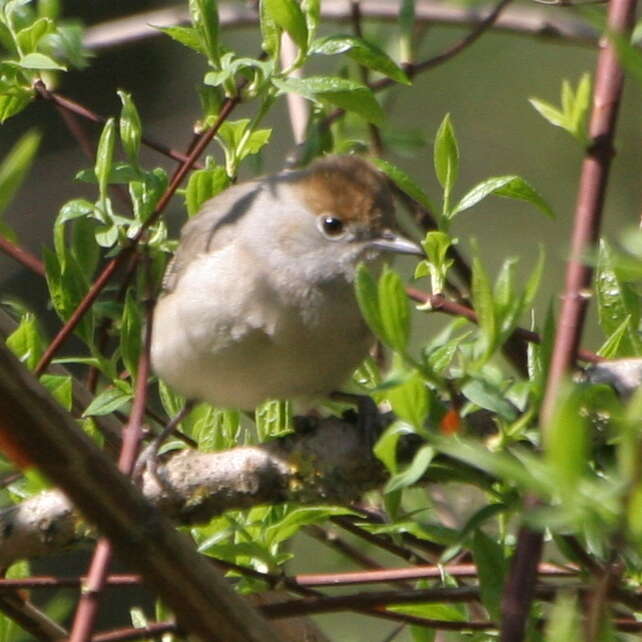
[0,0,642,642]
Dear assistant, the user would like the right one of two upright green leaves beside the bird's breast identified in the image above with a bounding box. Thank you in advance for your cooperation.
[377,266,410,352]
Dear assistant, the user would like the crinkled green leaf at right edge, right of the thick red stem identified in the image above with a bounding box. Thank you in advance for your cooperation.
[595,240,642,357]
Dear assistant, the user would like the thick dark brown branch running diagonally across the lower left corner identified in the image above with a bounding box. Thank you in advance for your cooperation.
[0,345,277,642]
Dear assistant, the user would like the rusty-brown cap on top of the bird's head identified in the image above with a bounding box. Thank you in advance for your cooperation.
[296,156,396,228]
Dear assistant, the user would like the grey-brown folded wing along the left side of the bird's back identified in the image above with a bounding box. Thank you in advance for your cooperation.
[162,181,261,294]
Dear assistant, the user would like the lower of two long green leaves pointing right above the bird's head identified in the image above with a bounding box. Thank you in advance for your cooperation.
[272,76,385,125]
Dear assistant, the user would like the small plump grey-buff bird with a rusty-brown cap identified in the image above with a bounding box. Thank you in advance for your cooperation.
[151,156,423,410]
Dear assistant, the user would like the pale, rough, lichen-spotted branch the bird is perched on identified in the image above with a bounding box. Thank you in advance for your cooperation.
[0,418,385,566]
